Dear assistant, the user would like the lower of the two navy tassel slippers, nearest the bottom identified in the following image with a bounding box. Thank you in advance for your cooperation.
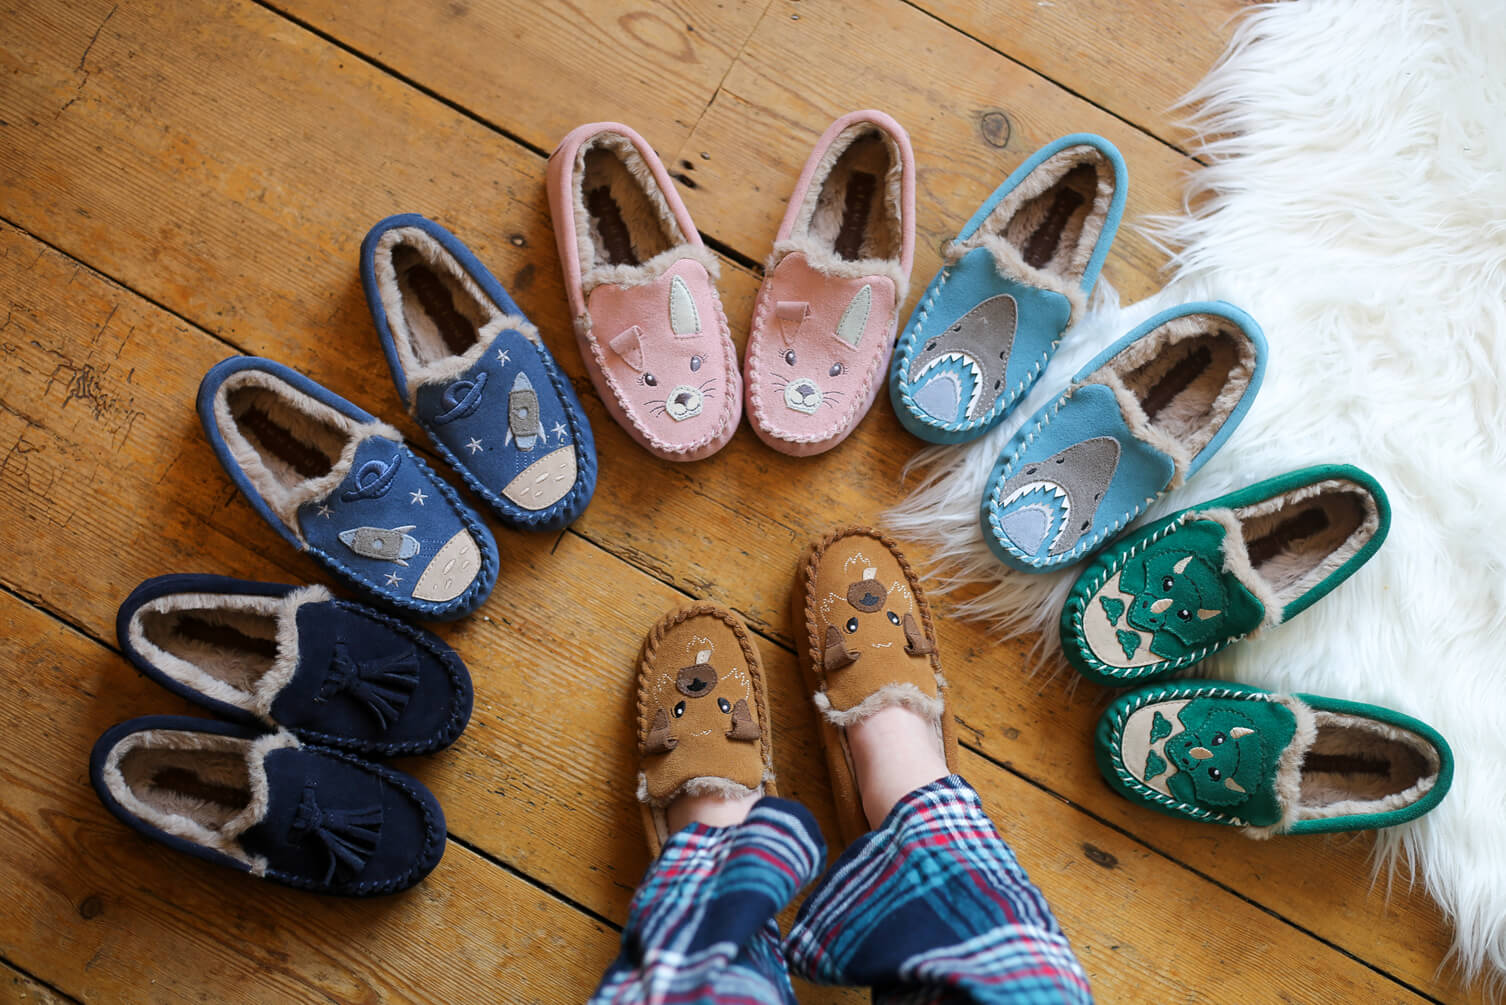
[89,716,444,897]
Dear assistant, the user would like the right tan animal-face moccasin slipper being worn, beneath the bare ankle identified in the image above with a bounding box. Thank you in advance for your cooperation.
[792,527,956,844]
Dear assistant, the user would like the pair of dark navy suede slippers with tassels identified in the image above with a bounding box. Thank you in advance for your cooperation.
[89,576,473,897]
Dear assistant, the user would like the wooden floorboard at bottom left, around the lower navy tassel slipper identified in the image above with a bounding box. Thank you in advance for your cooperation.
[0,594,616,1002]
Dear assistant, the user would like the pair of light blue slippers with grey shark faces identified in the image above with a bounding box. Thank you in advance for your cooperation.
[890,134,1267,573]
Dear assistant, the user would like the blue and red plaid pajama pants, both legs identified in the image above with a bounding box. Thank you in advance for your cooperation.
[592,774,1092,1005]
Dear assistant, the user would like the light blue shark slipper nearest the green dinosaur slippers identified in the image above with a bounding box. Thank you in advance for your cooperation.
[980,301,1265,573]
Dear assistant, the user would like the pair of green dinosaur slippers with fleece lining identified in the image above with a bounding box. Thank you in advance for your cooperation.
[1062,466,1453,838]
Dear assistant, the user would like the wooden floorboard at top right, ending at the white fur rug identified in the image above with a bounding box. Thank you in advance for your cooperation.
[916,0,1247,146]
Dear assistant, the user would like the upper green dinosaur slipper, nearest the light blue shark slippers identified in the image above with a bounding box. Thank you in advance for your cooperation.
[1062,464,1392,687]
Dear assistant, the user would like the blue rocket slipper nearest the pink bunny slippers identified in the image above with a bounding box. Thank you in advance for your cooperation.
[361,214,596,530]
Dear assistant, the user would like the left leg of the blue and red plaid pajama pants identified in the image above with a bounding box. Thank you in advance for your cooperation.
[592,799,827,1003]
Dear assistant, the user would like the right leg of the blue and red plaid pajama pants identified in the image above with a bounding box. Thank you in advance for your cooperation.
[785,774,1092,1005]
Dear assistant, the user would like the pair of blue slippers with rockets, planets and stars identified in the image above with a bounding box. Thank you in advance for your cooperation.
[199,214,596,621]
